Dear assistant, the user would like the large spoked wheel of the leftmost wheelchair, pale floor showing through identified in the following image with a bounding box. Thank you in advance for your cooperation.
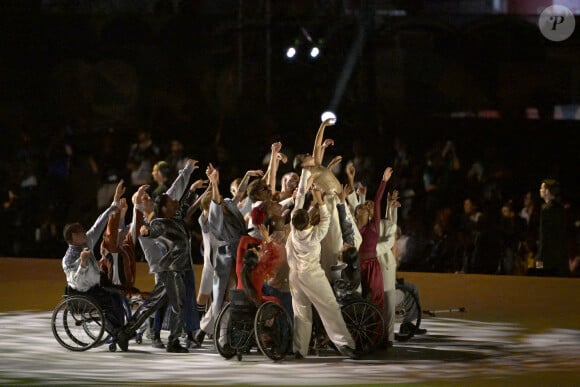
[51,296,105,351]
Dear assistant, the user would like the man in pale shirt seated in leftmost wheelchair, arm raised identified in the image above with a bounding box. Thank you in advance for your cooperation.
[62,180,125,337]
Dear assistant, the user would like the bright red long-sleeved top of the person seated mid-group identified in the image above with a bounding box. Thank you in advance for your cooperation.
[236,235,282,303]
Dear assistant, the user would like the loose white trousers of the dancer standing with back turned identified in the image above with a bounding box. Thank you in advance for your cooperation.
[289,268,355,356]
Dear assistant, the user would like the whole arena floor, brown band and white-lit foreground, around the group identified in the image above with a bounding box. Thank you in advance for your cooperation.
[0,258,580,386]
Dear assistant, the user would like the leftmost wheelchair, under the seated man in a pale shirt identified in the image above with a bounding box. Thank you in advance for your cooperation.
[50,286,142,352]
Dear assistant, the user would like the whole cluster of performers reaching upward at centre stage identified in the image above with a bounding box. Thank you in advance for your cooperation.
[62,118,416,358]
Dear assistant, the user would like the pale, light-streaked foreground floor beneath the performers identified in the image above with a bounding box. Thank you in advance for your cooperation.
[0,312,580,386]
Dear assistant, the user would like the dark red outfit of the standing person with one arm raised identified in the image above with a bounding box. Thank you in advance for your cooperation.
[359,180,387,310]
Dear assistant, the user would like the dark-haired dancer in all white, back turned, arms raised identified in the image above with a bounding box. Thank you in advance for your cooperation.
[286,169,357,358]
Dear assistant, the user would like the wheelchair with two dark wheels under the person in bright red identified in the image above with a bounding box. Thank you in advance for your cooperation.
[213,289,293,361]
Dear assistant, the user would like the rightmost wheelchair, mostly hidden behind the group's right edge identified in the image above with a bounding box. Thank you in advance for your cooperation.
[394,278,422,341]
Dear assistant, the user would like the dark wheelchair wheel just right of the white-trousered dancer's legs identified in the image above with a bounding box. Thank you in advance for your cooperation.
[341,300,385,354]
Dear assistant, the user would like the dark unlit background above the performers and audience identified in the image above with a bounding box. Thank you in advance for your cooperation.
[0,0,580,256]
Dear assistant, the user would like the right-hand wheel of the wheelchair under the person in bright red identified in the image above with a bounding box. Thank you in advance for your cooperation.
[254,301,292,360]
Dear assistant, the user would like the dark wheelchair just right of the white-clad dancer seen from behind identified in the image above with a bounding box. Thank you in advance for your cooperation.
[311,263,385,355]
